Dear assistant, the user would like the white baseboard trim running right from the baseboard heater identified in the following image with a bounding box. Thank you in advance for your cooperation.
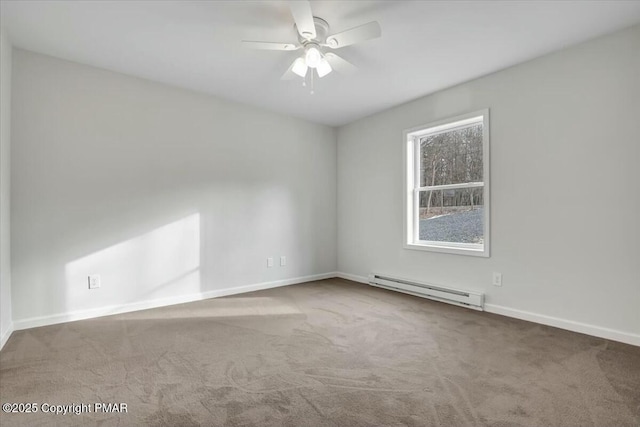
[484,304,640,346]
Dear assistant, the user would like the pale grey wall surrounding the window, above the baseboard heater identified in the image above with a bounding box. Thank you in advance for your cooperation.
[338,26,640,345]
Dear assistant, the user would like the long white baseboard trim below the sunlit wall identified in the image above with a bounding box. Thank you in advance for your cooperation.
[12,272,336,332]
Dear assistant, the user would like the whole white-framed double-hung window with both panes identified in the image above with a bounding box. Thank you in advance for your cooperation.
[403,110,489,257]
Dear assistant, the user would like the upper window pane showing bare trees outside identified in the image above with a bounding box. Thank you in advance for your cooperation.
[420,123,483,187]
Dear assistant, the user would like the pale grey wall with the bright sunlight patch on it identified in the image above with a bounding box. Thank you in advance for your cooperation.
[11,49,337,327]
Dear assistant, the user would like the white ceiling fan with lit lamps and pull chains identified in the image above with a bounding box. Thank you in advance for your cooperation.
[242,0,382,94]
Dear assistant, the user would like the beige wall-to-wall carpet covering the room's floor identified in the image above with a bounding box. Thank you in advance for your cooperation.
[0,279,640,427]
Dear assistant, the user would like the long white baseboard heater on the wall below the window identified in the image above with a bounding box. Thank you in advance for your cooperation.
[369,273,484,311]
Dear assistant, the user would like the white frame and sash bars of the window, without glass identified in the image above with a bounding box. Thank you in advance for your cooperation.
[402,108,491,257]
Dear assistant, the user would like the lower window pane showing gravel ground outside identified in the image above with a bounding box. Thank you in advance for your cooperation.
[419,187,484,243]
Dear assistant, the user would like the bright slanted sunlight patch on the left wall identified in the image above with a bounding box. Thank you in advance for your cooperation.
[65,214,200,309]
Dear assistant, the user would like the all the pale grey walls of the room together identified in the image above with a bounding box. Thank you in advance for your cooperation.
[2,26,640,339]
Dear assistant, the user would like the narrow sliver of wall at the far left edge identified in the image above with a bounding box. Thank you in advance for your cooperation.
[0,32,12,348]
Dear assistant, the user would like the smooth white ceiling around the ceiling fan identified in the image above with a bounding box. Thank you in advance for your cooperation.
[0,0,640,126]
